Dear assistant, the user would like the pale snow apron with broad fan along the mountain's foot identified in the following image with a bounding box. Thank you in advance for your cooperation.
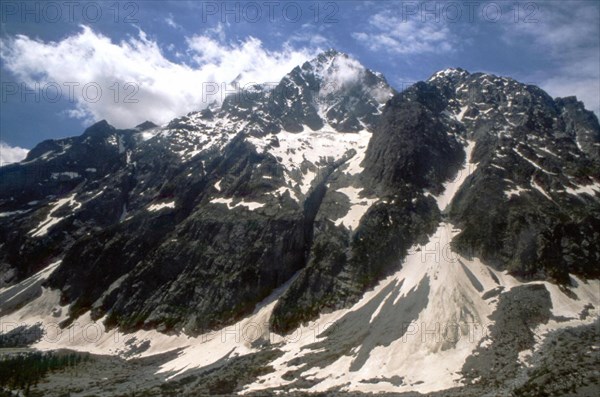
[2,223,600,393]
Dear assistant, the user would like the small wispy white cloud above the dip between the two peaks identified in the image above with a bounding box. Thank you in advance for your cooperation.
[352,11,456,54]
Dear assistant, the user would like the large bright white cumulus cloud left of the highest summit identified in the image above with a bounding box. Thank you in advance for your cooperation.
[0,26,318,128]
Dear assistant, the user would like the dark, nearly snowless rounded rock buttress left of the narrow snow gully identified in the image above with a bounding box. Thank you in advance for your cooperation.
[365,83,465,194]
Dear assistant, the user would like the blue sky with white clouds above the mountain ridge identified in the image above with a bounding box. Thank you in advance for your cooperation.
[0,0,600,164]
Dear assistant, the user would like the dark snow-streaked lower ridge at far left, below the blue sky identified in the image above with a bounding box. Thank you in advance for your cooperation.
[0,121,137,286]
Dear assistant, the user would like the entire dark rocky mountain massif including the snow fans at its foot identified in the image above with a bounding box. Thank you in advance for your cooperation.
[0,50,600,395]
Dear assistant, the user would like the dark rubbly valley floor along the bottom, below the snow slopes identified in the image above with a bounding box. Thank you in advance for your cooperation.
[0,322,600,397]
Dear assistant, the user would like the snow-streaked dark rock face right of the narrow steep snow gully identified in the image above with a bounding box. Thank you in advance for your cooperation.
[429,70,600,283]
